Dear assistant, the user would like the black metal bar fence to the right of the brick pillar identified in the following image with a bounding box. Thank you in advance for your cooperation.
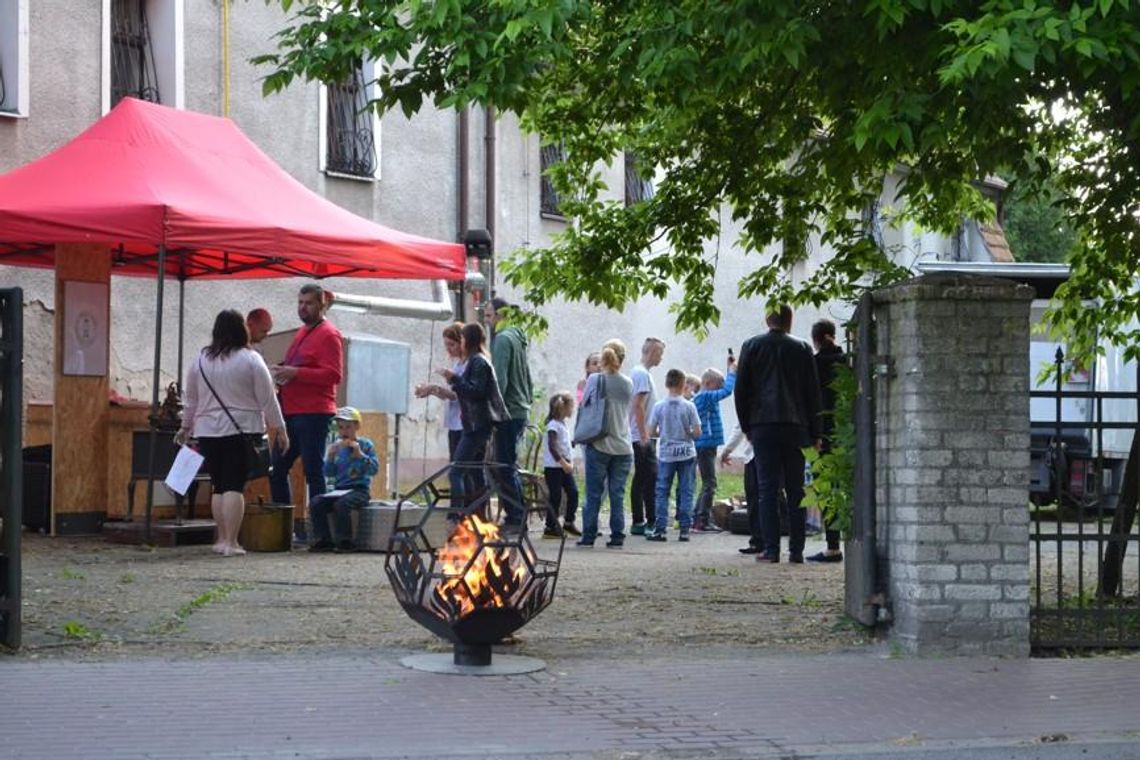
[1029,349,1140,651]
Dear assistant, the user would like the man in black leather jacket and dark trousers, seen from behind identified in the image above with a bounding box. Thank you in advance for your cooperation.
[735,305,821,563]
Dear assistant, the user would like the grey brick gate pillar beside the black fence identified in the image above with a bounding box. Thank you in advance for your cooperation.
[874,275,1033,656]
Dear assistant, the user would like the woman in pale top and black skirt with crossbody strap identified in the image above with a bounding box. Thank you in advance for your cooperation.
[174,309,288,557]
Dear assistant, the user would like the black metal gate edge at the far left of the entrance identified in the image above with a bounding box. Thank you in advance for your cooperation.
[0,287,24,648]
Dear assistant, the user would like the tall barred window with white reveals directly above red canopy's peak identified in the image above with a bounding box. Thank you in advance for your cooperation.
[103,0,185,113]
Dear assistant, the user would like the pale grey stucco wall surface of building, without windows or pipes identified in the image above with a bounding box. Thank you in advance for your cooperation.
[0,0,994,469]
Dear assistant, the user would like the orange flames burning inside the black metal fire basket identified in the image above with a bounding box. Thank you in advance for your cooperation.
[433,514,528,618]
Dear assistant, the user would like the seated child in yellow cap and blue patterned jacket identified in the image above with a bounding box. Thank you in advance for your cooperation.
[309,407,380,551]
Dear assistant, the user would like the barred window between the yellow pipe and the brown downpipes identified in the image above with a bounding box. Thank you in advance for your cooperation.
[325,66,376,178]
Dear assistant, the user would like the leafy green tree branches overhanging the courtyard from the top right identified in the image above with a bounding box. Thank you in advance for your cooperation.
[258,0,1140,351]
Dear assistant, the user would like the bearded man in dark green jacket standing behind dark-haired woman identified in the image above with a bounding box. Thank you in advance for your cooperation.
[483,297,535,526]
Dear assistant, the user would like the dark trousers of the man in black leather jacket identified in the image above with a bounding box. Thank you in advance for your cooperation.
[748,425,807,557]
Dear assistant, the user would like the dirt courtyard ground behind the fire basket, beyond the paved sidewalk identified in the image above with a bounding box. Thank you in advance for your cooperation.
[6,526,869,659]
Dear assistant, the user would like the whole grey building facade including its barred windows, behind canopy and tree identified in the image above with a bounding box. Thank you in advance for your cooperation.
[0,0,993,480]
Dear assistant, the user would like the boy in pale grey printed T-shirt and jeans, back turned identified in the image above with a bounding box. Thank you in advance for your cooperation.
[645,369,701,541]
